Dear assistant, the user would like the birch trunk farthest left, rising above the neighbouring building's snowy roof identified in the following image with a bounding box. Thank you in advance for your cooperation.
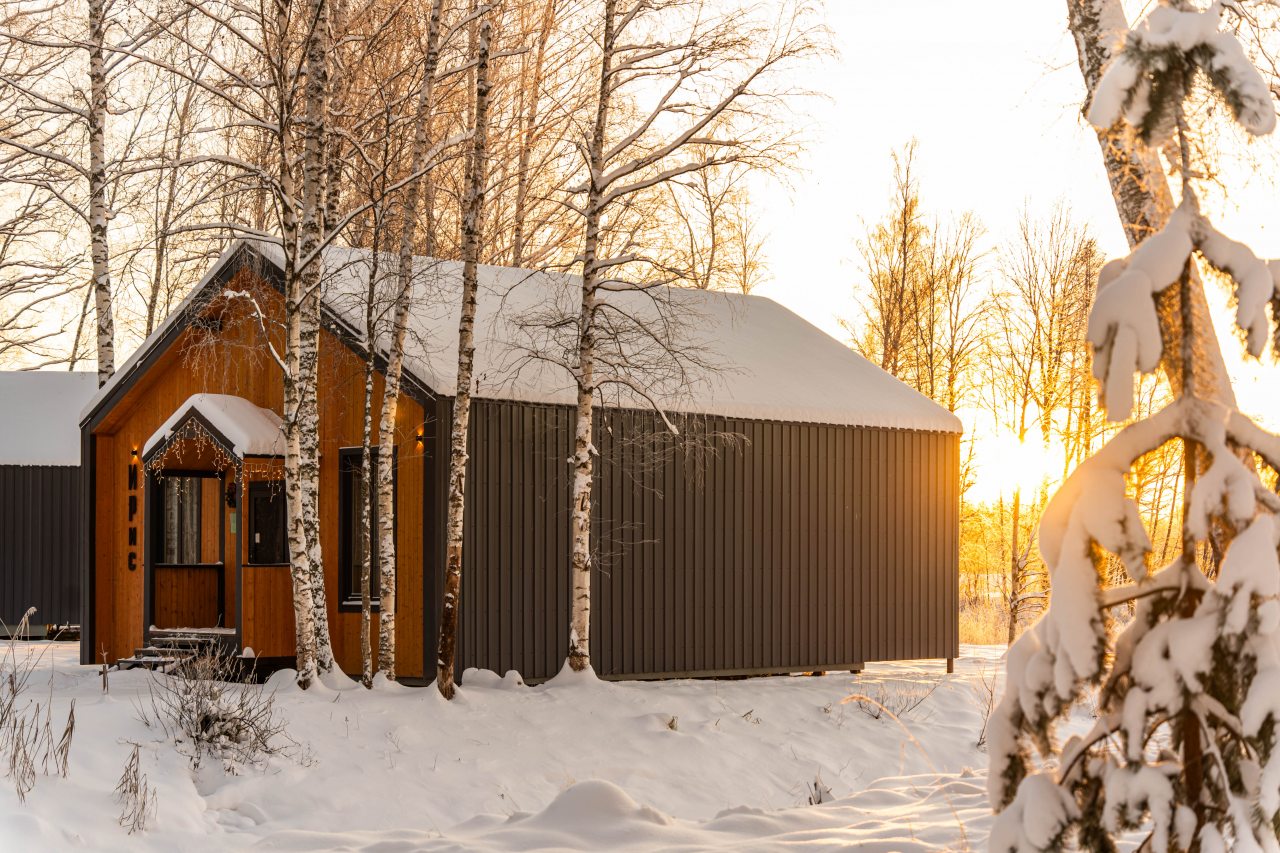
[88,0,115,386]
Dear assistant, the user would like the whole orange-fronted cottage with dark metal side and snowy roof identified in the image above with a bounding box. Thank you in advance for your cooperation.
[81,242,960,679]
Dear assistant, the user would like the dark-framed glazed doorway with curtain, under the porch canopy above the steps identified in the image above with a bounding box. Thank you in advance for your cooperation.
[147,471,227,628]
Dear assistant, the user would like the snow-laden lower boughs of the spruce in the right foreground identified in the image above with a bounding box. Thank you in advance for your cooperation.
[988,397,1280,850]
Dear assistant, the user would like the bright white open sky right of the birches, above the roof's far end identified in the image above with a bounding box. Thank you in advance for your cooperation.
[758,0,1280,500]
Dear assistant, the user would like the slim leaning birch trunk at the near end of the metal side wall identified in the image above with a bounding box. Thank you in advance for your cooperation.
[435,18,492,699]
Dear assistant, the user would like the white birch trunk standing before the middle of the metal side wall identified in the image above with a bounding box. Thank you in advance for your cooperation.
[568,0,617,672]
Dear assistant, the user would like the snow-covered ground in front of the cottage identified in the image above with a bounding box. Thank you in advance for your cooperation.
[0,644,1039,853]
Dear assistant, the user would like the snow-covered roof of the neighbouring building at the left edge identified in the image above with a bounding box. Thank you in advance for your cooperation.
[0,370,97,466]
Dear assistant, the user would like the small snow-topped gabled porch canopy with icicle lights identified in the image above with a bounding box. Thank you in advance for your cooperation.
[142,394,284,461]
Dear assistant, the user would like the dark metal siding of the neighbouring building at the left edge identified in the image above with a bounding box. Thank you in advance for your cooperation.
[0,465,81,626]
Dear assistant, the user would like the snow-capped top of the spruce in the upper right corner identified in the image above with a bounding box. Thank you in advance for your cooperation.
[1087,0,1276,145]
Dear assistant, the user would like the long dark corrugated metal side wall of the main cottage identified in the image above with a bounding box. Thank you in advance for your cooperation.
[429,400,959,679]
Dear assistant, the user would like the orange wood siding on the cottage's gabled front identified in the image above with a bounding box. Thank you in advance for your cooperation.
[93,270,425,675]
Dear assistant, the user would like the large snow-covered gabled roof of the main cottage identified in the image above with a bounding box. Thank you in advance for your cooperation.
[83,242,961,433]
